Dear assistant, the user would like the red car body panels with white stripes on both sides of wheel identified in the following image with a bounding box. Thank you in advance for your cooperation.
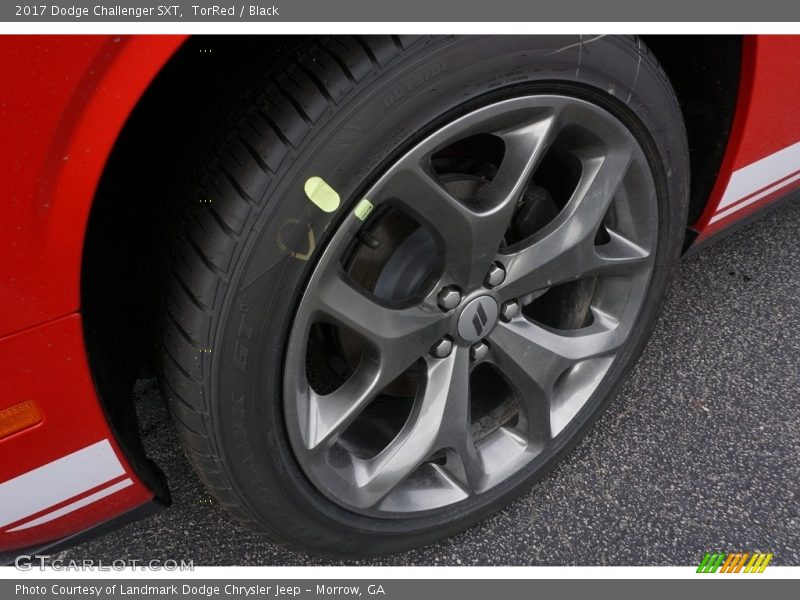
[0,36,800,551]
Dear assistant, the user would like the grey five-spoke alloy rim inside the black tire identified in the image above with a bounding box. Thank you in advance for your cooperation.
[283,95,658,518]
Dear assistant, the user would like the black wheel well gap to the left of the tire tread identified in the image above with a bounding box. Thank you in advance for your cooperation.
[81,36,296,501]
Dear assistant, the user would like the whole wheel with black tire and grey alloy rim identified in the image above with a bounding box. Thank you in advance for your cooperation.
[159,36,688,555]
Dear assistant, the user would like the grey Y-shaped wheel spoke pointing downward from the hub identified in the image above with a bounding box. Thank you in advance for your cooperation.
[353,348,480,508]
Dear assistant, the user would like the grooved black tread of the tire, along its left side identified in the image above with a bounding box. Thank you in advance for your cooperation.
[157,32,404,547]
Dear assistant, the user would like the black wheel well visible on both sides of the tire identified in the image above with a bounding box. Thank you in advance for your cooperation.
[81,36,742,499]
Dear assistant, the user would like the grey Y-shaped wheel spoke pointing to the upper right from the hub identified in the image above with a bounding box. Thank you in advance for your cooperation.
[501,148,650,298]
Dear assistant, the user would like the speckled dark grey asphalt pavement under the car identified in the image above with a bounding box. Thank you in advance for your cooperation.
[56,200,800,565]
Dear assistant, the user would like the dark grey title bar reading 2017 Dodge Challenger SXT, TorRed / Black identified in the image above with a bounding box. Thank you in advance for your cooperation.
[0,0,800,23]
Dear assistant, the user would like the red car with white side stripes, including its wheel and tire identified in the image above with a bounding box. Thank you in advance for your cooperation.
[0,36,800,559]
